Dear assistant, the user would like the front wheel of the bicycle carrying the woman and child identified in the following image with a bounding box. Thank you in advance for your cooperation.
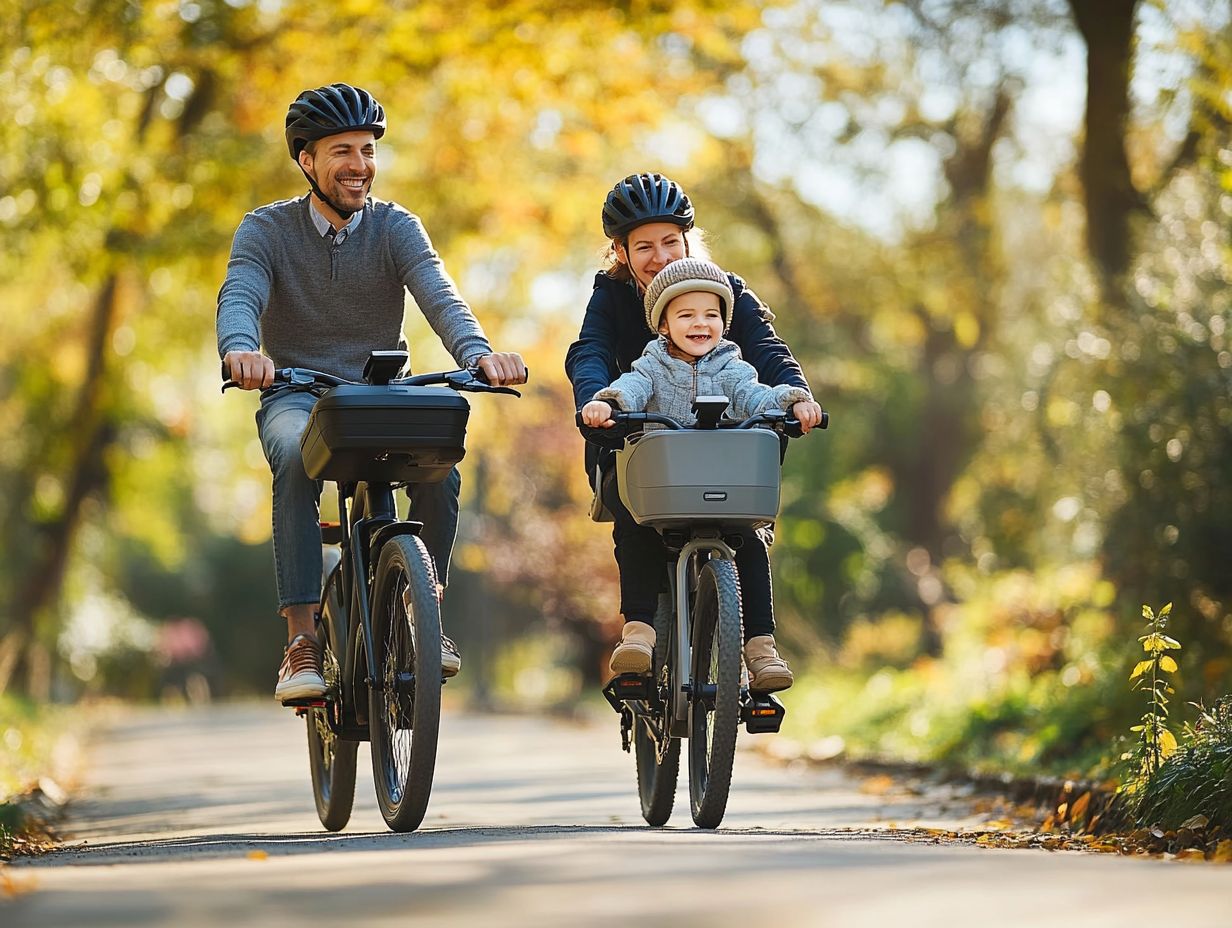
[689,558,743,828]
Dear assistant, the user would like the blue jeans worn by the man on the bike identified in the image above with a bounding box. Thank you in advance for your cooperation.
[256,389,462,611]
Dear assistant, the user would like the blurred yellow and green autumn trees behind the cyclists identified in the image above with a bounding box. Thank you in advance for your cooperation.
[0,0,1232,770]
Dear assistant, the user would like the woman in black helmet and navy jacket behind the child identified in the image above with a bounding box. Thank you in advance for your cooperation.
[564,174,821,691]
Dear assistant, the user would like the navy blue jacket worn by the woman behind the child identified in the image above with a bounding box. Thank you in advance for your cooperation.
[564,271,808,477]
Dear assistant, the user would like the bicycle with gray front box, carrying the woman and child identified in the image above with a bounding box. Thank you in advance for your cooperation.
[578,397,829,828]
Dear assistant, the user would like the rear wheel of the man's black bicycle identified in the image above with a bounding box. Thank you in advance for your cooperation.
[304,574,360,832]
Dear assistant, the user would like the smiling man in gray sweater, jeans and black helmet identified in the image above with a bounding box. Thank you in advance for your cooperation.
[217,84,526,702]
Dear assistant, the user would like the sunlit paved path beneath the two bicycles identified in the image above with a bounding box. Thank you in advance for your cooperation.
[0,705,1232,928]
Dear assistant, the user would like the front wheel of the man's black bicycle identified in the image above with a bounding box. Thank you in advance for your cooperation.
[368,535,441,832]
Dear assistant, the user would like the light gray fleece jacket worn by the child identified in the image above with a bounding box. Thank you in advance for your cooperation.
[594,335,813,425]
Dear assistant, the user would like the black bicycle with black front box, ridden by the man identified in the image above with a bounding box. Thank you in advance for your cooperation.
[223,351,521,832]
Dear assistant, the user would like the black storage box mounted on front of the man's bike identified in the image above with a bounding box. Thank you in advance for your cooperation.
[299,385,471,483]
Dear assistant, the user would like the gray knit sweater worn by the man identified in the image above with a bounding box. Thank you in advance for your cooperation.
[217,196,492,381]
